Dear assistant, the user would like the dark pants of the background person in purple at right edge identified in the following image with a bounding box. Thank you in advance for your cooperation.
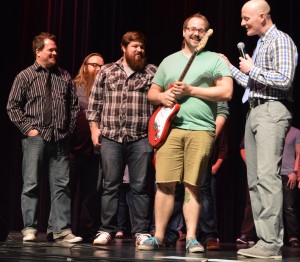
[281,176,300,239]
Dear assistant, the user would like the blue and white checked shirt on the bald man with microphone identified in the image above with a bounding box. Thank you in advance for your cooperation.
[230,25,298,102]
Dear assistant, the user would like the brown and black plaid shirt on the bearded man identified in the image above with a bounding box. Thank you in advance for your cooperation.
[86,58,157,143]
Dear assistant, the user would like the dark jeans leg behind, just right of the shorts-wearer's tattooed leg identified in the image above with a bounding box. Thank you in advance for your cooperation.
[197,161,218,244]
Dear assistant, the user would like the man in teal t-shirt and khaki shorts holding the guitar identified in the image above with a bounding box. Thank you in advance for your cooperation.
[139,11,233,252]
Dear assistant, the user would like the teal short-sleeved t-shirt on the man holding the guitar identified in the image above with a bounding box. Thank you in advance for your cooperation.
[152,51,231,132]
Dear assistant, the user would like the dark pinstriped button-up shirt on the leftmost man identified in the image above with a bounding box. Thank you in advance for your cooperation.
[7,62,79,141]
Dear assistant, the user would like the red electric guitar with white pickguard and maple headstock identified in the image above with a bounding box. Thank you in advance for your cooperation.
[148,29,213,148]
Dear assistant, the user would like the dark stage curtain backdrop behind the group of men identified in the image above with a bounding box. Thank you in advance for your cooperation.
[0,0,300,241]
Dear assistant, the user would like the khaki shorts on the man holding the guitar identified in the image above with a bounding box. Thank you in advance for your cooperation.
[155,128,215,186]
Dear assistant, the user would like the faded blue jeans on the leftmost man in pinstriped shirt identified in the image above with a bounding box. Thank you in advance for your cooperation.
[21,136,71,238]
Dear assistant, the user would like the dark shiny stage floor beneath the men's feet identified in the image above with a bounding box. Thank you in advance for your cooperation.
[0,232,300,262]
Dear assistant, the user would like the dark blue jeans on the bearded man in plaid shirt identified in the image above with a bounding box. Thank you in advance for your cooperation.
[100,137,153,236]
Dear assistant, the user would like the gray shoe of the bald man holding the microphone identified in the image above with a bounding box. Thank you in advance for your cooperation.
[237,244,282,259]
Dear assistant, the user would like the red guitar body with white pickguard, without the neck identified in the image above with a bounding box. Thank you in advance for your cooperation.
[148,104,180,148]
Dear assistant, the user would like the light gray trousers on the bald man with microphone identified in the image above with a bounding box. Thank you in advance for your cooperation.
[242,102,291,253]
